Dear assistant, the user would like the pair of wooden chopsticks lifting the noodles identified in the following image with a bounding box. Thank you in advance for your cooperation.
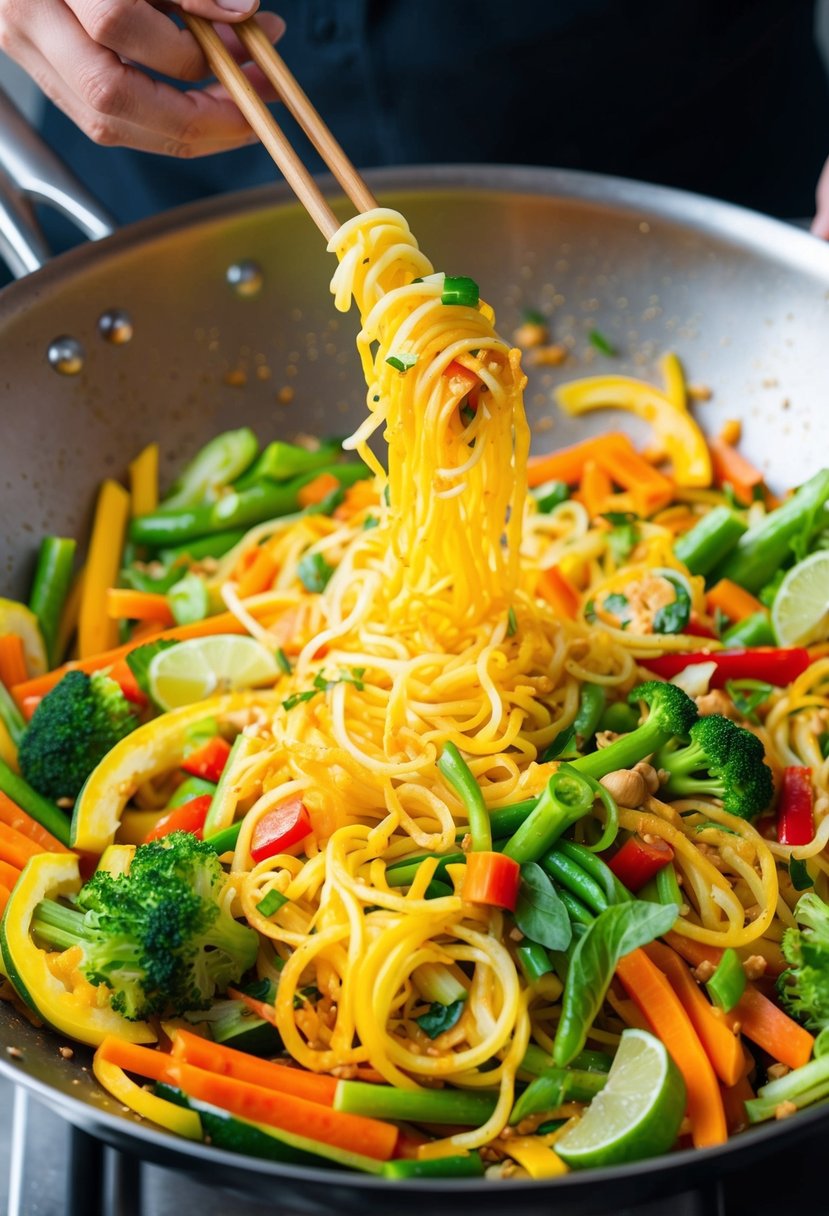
[181,13,377,241]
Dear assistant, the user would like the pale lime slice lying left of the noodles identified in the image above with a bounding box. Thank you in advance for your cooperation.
[147,634,280,709]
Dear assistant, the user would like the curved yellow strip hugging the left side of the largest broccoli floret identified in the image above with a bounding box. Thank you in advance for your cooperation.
[0,852,156,1047]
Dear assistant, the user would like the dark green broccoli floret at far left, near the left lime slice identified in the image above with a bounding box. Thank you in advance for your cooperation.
[18,671,139,801]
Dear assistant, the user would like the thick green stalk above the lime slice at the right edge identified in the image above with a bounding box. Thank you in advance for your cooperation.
[712,468,829,592]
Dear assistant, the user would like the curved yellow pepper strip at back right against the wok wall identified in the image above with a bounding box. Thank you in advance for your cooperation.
[556,376,712,486]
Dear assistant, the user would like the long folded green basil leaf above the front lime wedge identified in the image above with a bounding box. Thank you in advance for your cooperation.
[553,900,679,1068]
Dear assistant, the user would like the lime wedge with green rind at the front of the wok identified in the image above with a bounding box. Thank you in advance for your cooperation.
[556,1030,686,1170]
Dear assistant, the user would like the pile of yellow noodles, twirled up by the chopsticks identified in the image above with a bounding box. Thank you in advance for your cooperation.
[195,210,811,1148]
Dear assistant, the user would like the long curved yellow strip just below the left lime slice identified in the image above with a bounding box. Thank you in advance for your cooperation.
[71,692,277,854]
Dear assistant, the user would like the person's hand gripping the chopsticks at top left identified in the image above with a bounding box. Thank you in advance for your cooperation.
[0,0,284,157]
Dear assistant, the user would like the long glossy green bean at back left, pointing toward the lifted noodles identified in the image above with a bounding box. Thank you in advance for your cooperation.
[130,463,371,548]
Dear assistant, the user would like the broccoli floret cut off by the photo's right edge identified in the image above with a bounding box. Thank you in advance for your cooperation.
[777,891,829,1030]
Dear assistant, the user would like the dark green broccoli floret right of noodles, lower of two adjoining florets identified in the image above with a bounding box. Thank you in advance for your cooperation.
[653,714,774,820]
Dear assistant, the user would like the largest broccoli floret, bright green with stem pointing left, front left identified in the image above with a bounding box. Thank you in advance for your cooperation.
[33,832,259,1020]
